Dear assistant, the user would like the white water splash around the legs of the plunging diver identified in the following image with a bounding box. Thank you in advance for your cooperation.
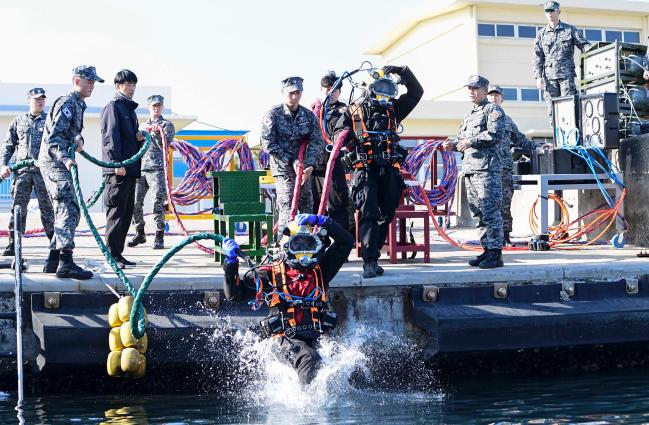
[214,318,441,410]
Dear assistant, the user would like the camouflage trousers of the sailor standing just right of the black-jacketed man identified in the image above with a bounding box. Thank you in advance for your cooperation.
[133,170,167,233]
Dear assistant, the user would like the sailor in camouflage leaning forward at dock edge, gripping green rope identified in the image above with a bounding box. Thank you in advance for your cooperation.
[38,65,104,280]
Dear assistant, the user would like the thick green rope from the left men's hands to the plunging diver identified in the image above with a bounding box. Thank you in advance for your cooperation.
[68,133,225,339]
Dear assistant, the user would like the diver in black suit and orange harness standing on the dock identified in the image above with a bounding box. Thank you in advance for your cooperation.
[335,66,424,279]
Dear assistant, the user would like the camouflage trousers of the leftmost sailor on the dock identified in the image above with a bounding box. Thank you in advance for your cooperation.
[9,169,54,239]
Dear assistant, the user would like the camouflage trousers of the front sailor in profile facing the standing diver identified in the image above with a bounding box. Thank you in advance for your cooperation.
[464,170,503,249]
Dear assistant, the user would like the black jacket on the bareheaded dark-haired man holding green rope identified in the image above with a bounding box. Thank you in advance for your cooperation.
[100,93,143,177]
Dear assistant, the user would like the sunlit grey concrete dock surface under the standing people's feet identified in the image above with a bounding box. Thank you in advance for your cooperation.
[0,213,649,292]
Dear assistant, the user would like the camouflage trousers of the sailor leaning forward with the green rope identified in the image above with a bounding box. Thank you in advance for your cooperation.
[41,168,80,249]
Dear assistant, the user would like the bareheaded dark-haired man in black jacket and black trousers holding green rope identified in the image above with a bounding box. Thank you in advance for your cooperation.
[100,69,144,268]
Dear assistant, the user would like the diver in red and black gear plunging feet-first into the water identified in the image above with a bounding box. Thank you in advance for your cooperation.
[221,214,354,384]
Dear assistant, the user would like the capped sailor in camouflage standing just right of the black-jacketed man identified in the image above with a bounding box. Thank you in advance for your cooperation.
[128,94,176,249]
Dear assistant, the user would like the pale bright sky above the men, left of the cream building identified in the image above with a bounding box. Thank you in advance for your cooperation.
[0,0,420,144]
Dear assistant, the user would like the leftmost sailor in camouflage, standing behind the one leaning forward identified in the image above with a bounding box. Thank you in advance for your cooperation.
[0,87,58,266]
